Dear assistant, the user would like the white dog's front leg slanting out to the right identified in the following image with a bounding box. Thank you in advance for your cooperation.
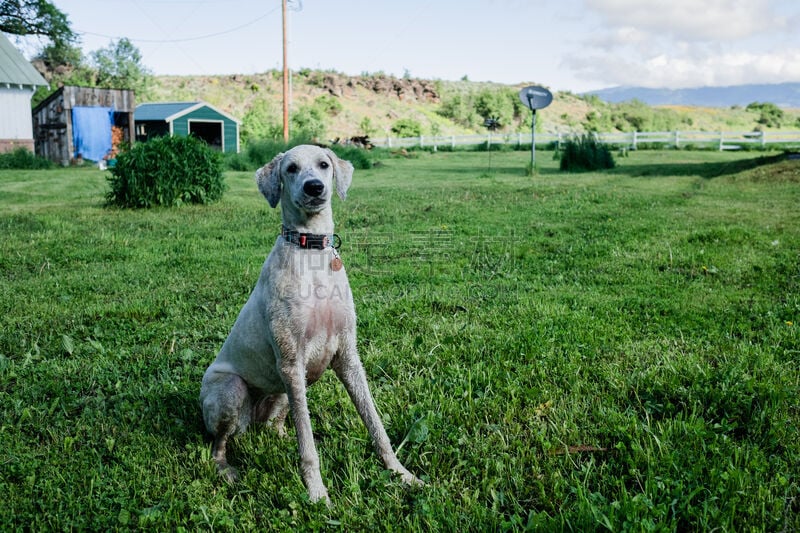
[332,346,424,485]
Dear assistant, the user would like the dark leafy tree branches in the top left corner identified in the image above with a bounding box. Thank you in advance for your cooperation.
[0,0,77,47]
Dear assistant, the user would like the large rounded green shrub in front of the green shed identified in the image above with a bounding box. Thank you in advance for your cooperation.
[106,136,225,207]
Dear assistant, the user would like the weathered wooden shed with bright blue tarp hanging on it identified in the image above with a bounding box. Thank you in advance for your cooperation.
[33,86,135,166]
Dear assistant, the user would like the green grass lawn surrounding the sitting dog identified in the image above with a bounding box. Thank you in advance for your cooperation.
[0,152,800,531]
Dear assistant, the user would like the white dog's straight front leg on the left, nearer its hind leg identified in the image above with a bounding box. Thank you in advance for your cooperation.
[283,365,331,505]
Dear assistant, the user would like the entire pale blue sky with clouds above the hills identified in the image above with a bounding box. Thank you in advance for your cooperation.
[29,0,800,92]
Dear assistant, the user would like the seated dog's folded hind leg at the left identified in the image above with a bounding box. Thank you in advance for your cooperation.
[200,374,252,482]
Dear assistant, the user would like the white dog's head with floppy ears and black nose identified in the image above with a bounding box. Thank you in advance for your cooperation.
[256,144,353,214]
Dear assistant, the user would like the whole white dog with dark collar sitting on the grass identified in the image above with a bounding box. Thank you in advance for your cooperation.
[200,145,422,503]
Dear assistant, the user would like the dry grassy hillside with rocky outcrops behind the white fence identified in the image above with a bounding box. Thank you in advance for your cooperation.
[145,70,800,140]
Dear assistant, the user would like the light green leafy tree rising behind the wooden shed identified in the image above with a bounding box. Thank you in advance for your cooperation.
[91,38,150,93]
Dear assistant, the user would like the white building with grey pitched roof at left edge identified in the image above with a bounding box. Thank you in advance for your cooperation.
[0,33,47,153]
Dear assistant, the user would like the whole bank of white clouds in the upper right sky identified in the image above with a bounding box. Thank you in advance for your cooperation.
[563,0,800,88]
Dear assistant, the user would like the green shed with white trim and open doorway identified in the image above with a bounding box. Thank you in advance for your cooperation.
[133,102,239,153]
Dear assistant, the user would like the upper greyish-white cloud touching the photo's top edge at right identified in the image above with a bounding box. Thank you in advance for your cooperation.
[585,0,788,41]
